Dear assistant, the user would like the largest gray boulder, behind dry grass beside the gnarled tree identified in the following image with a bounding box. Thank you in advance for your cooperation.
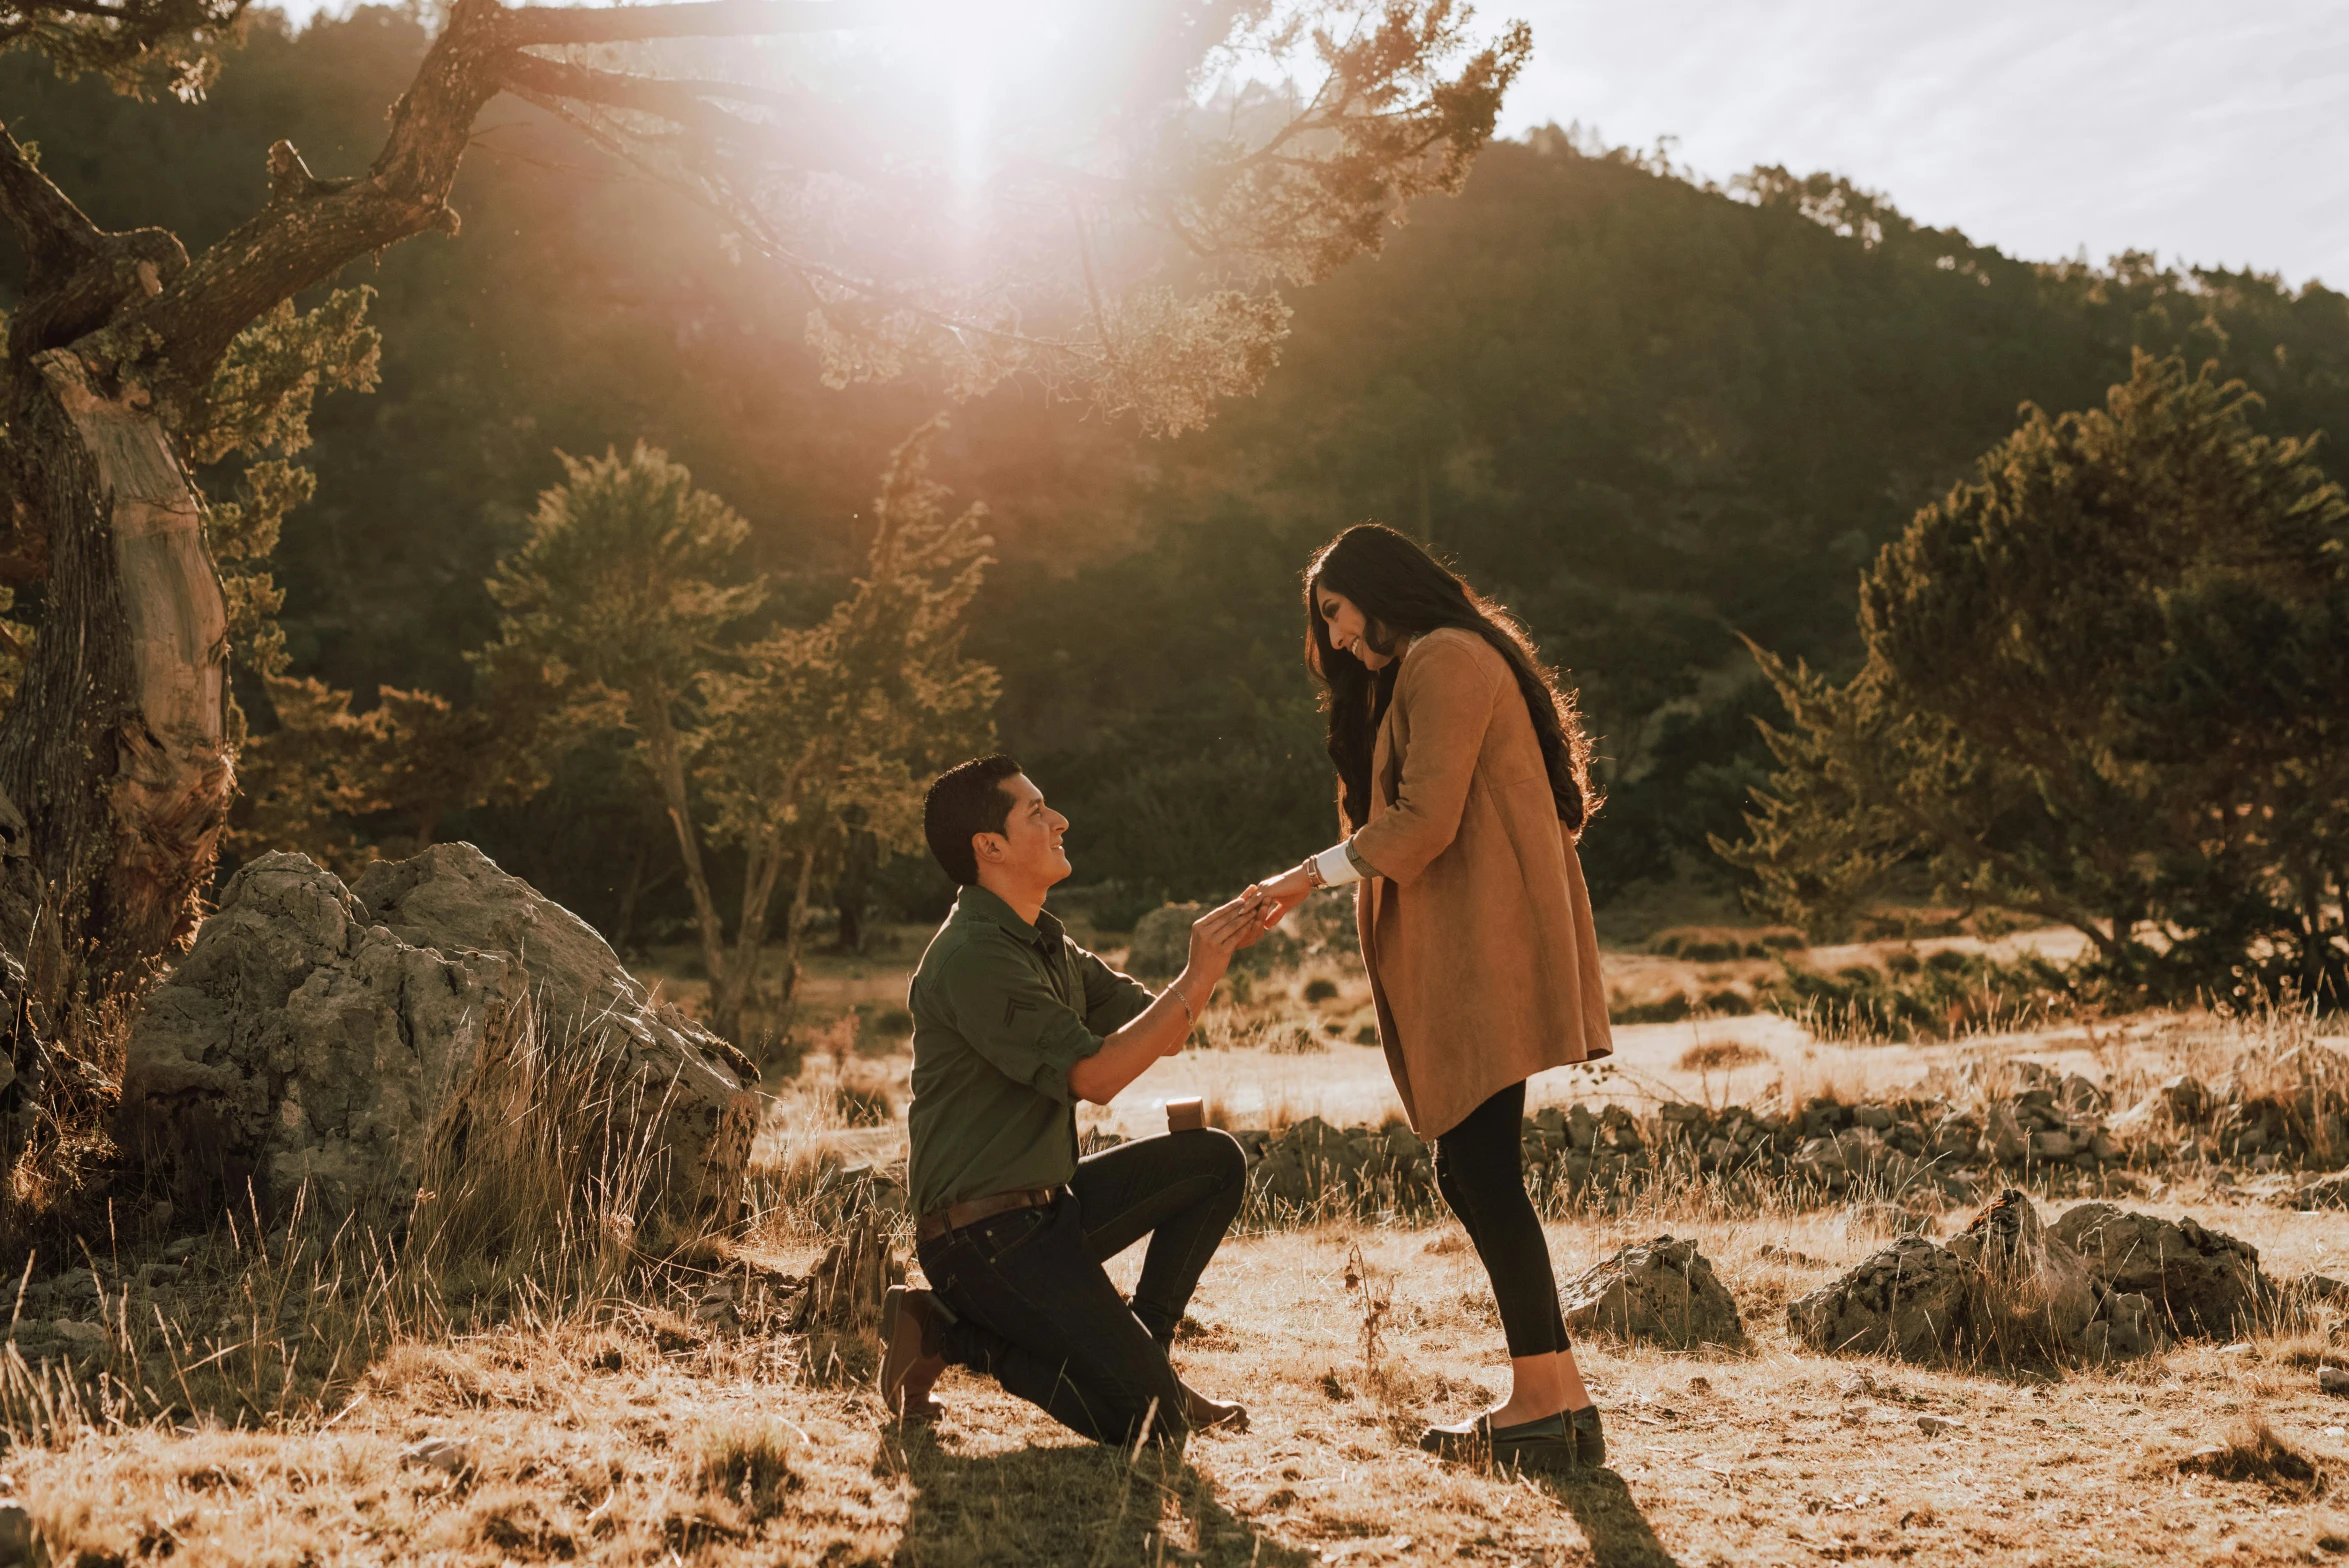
[120,843,759,1223]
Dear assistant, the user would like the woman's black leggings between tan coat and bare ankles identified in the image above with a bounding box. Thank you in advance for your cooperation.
[1435,1082,1569,1357]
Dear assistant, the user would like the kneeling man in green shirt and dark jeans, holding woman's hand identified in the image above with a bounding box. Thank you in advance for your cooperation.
[881,756,1264,1444]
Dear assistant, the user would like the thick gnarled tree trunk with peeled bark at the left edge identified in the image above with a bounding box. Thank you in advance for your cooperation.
[0,350,233,1000]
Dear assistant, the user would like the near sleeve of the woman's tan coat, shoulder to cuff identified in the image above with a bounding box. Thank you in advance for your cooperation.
[1351,641,1506,887]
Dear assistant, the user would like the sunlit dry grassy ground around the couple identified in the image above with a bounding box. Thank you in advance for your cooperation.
[18,924,2349,1568]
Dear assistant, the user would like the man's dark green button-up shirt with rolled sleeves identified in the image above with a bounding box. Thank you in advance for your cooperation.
[907,887,1156,1214]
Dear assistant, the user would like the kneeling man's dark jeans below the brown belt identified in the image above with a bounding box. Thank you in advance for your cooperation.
[918,1129,1247,1444]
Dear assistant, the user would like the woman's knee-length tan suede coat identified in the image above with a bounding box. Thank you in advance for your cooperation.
[1353,627,1614,1138]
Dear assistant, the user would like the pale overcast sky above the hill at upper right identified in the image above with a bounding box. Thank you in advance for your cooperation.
[1478,0,2349,289]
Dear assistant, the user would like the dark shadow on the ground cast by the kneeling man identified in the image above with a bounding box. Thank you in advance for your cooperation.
[881,1430,1315,1568]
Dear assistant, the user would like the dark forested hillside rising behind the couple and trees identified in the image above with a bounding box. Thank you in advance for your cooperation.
[0,9,2349,939]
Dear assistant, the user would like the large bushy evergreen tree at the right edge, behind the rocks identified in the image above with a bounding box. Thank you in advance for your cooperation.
[1722,354,2349,1005]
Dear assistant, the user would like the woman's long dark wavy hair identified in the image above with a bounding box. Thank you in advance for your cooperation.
[1306,523,1600,833]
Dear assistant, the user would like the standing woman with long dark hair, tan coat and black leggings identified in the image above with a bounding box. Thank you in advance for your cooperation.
[1264,523,1614,1469]
